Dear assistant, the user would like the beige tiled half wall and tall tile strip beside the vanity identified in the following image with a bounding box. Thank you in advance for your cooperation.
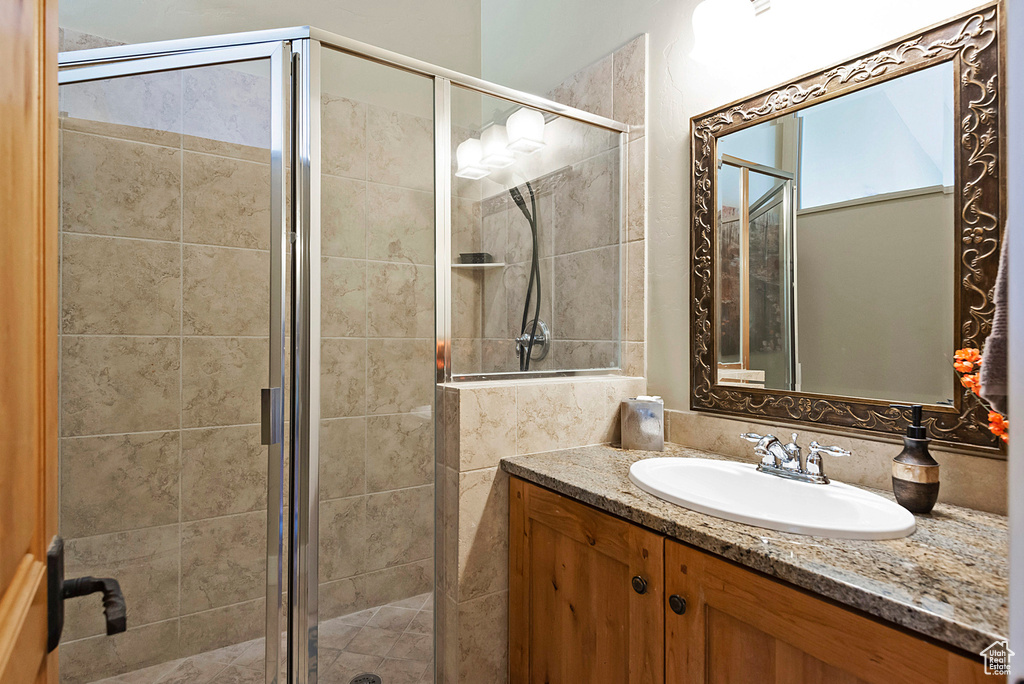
[436,36,647,684]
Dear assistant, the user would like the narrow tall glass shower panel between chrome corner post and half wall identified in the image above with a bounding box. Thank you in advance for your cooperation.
[290,40,435,684]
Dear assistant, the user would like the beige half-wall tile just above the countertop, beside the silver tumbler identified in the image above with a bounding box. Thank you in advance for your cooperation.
[516,377,646,454]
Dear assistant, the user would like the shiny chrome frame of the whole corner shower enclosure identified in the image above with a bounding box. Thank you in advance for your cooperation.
[58,27,630,684]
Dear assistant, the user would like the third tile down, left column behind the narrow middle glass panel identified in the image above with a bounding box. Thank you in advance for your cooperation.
[321,257,368,337]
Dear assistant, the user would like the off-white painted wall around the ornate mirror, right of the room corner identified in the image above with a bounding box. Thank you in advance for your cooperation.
[480,0,987,409]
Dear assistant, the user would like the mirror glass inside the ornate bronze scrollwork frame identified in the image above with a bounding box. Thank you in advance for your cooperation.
[716,62,956,404]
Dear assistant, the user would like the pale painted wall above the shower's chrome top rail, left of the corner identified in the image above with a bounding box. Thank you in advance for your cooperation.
[59,0,480,76]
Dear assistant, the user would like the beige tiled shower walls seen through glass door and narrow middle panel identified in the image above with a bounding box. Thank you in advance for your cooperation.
[60,33,433,682]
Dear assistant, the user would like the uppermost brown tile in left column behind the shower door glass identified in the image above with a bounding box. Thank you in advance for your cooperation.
[60,131,181,240]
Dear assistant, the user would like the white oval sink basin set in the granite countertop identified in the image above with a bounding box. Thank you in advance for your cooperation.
[630,458,914,540]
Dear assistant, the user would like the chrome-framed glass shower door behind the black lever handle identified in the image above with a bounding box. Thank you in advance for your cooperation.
[59,43,289,683]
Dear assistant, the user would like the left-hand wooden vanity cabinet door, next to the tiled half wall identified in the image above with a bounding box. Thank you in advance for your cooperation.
[509,478,665,684]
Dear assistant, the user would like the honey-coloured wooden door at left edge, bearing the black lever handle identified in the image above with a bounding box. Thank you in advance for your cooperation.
[0,0,59,684]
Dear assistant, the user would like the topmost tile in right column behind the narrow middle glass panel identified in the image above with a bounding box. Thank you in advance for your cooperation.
[367,105,434,190]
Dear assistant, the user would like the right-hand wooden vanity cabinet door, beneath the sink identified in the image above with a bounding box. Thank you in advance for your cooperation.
[665,541,991,684]
